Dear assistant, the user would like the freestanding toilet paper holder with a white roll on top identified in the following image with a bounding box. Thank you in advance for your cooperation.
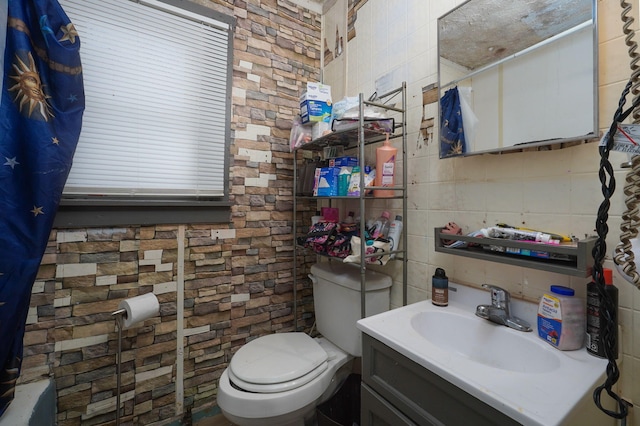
[111,293,160,426]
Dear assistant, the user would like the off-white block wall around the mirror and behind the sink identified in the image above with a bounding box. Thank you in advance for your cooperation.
[325,0,640,426]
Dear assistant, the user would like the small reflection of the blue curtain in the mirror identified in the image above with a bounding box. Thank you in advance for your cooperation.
[440,87,466,158]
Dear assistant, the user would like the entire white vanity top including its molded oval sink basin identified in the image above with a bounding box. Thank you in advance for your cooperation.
[358,283,614,426]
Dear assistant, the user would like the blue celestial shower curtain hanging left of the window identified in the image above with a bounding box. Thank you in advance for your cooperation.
[0,0,84,415]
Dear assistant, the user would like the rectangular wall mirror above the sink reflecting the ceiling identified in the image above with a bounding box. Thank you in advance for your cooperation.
[438,0,598,158]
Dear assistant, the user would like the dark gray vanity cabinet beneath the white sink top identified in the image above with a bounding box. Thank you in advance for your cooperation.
[361,333,520,426]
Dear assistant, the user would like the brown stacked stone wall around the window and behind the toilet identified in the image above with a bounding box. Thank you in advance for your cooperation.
[20,0,320,426]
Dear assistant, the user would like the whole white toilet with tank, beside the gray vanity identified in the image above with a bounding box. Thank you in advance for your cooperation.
[218,262,391,426]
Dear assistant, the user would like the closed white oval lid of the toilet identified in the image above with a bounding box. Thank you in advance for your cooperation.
[229,333,327,392]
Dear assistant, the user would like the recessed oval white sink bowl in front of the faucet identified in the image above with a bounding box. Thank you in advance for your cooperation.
[411,310,560,373]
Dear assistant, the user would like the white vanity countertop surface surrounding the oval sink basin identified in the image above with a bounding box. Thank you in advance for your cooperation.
[358,283,607,426]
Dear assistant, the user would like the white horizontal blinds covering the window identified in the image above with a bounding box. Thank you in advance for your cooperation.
[60,0,232,200]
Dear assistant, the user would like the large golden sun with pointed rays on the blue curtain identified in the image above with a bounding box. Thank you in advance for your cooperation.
[9,52,53,121]
